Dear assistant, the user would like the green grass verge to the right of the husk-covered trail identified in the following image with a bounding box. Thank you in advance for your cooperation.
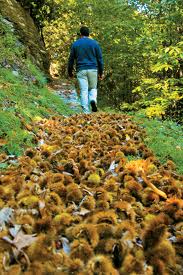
[102,108,183,174]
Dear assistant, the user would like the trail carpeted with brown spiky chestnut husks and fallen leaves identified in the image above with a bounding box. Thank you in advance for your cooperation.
[0,84,183,275]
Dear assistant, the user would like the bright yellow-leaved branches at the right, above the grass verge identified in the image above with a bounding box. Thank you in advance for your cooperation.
[121,42,183,121]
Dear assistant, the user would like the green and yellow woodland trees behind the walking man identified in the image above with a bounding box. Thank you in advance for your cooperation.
[29,0,183,121]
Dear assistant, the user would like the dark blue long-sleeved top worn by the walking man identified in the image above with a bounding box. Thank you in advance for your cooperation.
[68,37,104,76]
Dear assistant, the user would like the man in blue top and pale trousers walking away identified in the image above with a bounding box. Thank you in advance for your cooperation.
[68,26,103,114]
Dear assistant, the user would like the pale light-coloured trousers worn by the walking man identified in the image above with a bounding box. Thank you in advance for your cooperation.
[77,69,98,114]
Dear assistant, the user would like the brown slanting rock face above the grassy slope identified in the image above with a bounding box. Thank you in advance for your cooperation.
[0,0,49,73]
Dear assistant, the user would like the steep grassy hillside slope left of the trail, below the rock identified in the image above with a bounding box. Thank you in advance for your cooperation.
[0,17,72,155]
